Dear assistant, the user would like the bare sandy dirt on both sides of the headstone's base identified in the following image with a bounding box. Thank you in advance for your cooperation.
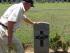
[24,44,70,53]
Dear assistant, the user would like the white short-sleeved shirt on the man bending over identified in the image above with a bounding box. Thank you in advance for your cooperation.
[0,2,26,31]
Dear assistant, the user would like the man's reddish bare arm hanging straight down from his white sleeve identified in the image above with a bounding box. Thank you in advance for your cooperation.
[8,21,15,47]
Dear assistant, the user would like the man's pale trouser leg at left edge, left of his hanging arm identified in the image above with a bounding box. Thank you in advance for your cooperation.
[0,29,7,53]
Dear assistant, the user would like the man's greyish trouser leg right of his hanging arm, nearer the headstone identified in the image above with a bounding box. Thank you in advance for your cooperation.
[13,36,24,53]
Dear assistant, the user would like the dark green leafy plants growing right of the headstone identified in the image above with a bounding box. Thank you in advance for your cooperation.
[50,33,70,51]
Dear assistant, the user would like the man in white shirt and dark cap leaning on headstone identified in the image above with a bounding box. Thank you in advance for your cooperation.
[0,0,35,53]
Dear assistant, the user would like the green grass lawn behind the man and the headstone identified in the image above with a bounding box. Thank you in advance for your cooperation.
[0,2,70,43]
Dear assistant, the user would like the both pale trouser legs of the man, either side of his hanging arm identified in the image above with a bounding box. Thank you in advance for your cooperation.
[0,26,24,53]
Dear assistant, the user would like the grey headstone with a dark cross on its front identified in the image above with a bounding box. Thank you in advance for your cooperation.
[34,22,49,53]
